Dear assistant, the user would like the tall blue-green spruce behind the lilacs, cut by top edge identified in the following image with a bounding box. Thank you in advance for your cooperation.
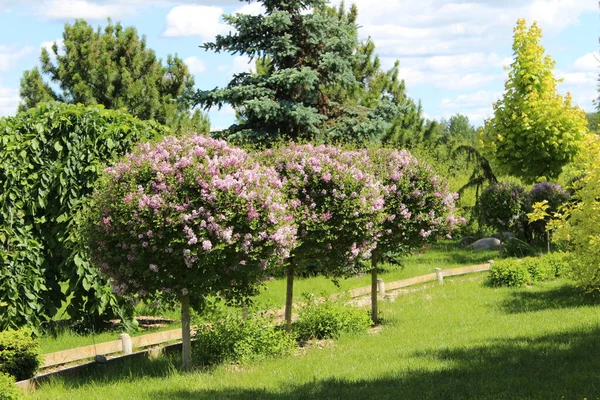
[192,0,386,142]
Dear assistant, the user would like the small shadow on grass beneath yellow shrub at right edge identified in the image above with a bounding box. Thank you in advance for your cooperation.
[500,284,600,314]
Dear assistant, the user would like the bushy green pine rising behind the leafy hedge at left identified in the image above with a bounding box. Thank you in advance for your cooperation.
[19,20,206,131]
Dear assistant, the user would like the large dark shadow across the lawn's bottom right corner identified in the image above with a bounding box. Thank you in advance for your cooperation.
[152,327,600,400]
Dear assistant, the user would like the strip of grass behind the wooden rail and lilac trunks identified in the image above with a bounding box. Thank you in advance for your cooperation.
[255,241,498,308]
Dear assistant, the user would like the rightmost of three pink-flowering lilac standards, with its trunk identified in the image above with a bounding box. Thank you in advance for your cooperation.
[368,148,464,323]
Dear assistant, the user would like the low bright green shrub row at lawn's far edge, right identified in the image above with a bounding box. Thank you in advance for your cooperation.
[487,253,570,287]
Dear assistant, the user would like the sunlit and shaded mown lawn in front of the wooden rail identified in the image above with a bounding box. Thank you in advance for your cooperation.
[31,274,600,400]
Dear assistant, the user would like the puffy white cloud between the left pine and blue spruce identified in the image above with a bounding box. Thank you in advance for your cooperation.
[162,5,229,39]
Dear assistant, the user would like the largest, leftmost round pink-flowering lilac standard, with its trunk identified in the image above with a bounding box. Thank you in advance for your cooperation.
[87,135,296,366]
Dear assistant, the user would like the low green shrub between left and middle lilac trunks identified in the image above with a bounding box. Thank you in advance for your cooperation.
[192,313,296,366]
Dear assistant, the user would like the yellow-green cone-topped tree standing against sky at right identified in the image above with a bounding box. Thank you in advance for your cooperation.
[482,19,587,183]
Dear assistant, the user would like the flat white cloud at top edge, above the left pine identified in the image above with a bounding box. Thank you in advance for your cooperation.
[35,0,134,20]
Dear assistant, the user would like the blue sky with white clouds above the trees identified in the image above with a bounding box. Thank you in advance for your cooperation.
[0,0,600,130]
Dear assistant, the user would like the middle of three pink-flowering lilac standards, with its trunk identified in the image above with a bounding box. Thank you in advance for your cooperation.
[262,143,384,330]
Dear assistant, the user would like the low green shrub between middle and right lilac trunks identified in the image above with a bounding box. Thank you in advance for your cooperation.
[292,295,371,341]
